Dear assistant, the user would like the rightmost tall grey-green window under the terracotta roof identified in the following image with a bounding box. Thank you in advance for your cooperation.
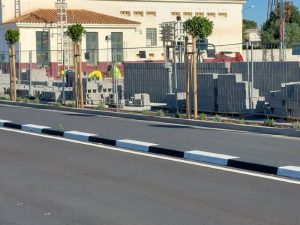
[111,32,123,62]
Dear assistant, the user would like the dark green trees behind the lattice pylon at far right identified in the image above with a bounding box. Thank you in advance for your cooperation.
[260,3,300,47]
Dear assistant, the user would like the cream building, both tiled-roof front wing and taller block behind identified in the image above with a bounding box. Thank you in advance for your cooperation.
[0,0,246,77]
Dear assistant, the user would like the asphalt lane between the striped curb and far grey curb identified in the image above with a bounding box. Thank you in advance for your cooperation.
[0,105,300,166]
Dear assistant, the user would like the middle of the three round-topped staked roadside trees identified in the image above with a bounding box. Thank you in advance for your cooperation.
[67,24,86,108]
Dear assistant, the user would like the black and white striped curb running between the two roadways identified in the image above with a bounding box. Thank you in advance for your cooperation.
[0,119,300,179]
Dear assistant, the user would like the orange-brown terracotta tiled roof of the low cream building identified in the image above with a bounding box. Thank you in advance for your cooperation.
[7,9,140,25]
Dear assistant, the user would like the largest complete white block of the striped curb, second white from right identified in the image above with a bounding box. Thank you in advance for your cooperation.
[184,150,239,166]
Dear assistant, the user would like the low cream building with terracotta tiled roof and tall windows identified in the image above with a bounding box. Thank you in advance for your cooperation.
[0,9,140,75]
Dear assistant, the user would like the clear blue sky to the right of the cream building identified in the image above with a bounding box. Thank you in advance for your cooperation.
[243,0,300,26]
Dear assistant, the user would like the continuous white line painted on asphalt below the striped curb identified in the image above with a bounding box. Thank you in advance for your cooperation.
[0,128,300,185]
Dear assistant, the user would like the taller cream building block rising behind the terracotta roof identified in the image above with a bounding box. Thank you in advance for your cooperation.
[0,0,245,47]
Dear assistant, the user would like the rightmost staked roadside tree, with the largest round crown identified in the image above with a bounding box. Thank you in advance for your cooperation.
[183,16,214,119]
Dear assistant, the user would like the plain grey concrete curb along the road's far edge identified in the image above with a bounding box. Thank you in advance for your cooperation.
[1,104,300,141]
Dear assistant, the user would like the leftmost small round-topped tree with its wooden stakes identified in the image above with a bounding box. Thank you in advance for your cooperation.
[5,29,20,101]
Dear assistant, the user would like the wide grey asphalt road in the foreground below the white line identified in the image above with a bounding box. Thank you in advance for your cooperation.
[0,130,300,225]
